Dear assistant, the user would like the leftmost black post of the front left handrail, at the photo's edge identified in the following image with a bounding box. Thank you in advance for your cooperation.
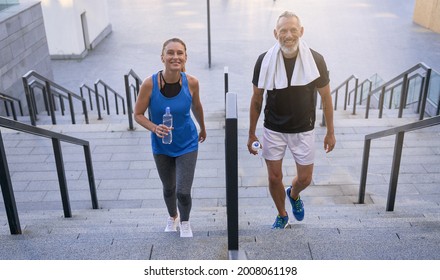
[0,130,21,234]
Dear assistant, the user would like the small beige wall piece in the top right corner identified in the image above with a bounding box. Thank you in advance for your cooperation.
[413,0,440,33]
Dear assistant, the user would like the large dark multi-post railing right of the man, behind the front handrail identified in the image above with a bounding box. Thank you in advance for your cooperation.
[365,63,432,120]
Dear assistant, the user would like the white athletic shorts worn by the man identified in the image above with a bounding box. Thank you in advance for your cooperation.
[261,128,315,165]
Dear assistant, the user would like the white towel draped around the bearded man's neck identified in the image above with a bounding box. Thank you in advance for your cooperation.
[258,40,320,90]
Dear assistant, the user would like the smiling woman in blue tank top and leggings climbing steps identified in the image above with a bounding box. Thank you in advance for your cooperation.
[134,38,206,237]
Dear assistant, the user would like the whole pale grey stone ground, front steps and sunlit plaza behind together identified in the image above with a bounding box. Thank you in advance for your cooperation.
[0,0,440,264]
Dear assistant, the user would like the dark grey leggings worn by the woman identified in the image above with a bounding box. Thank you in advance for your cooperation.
[154,151,197,221]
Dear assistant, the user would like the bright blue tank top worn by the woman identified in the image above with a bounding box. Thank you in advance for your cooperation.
[148,72,199,157]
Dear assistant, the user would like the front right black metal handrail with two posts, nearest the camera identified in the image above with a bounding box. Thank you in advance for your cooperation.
[358,116,440,211]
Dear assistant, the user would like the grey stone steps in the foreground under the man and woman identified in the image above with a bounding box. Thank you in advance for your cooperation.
[0,108,440,260]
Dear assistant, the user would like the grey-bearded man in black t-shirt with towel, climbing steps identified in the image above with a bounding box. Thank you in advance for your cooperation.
[247,12,336,229]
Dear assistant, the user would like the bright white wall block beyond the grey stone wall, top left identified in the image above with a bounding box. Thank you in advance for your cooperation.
[20,0,112,59]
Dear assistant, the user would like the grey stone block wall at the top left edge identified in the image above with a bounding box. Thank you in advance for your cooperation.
[0,2,53,115]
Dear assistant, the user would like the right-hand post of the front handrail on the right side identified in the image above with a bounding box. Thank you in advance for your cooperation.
[387,131,405,211]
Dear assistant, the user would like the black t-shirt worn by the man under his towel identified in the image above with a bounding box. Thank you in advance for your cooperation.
[252,49,330,133]
